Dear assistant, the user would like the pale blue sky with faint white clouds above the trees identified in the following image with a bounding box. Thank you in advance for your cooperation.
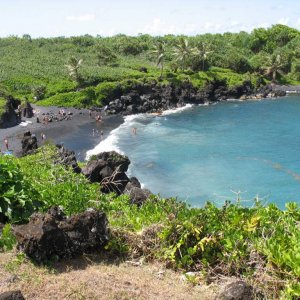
[0,0,300,38]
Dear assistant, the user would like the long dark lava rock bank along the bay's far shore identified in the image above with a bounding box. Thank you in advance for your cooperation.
[105,80,287,116]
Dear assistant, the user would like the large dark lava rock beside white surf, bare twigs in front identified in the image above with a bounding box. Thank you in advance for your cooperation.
[82,151,130,195]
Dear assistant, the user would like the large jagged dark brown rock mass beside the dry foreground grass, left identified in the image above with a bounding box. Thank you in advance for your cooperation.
[14,207,109,263]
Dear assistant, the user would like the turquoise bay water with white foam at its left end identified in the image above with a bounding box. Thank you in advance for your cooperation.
[88,96,300,207]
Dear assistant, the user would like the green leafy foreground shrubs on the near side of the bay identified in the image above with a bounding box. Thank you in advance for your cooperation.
[0,146,300,299]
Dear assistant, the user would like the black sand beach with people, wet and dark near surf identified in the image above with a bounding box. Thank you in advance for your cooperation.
[0,105,123,160]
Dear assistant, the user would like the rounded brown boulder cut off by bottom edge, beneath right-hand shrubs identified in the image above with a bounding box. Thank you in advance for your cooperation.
[215,280,254,300]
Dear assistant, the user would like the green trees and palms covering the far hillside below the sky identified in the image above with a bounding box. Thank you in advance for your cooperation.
[0,25,300,109]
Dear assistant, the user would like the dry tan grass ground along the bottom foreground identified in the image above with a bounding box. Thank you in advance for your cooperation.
[0,252,216,300]
